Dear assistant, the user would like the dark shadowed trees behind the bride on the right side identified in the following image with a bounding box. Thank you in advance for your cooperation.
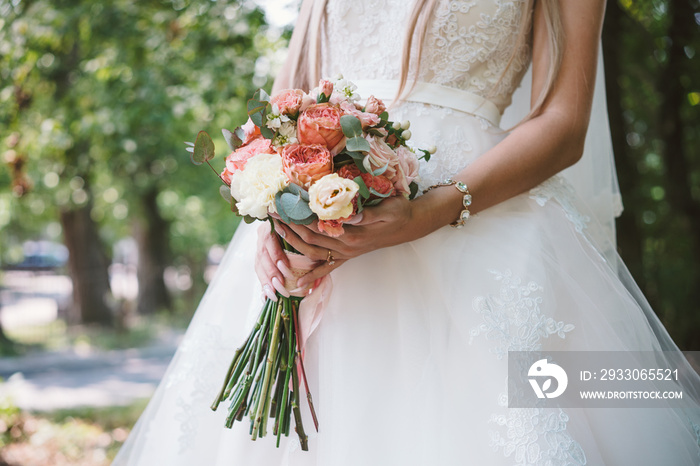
[603,0,700,350]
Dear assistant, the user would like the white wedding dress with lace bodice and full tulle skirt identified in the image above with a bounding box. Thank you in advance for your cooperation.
[114,0,700,466]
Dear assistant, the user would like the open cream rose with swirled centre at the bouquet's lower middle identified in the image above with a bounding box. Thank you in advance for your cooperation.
[308,173,360,220]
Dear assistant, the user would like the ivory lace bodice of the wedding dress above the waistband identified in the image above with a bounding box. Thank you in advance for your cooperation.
[322,0,530,112]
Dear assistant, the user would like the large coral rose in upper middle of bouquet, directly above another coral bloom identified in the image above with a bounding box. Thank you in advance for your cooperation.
[297,103,345,155]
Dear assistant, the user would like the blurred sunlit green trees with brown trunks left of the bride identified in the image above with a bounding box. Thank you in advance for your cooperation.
[0,0,284,322]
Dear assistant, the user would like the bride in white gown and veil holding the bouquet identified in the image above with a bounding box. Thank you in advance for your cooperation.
[114,0,700,466]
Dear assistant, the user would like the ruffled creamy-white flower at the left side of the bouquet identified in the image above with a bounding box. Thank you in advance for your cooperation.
[231,154,289,220]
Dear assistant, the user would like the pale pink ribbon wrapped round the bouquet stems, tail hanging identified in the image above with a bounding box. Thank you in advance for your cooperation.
[284,251,333,352]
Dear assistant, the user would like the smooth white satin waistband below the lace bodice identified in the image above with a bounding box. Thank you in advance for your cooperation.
[353,79,501,126]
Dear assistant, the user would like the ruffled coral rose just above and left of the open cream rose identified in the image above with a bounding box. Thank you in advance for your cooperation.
[282,144,333,190]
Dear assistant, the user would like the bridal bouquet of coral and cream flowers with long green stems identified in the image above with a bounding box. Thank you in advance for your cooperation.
[187,77,434,450]
